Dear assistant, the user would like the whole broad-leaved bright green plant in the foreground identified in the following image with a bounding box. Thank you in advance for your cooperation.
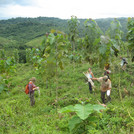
[59,103,105,132]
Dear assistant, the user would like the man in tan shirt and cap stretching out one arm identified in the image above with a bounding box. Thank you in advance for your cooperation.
[92,75,111,104]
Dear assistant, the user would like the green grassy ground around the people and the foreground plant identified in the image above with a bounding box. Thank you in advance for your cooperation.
[0,59,134,134]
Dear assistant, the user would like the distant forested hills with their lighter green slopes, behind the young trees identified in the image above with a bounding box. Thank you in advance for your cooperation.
[0,17,127,62]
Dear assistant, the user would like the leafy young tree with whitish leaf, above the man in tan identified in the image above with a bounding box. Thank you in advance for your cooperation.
[99,19,123,67]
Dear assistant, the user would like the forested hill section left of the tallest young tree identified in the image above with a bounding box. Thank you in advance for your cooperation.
[0,17,67,42]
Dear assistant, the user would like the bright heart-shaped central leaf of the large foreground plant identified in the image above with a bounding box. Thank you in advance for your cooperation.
[74,104,93,120]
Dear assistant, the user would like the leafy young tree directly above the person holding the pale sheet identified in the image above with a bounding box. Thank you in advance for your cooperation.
[83,19,102,64]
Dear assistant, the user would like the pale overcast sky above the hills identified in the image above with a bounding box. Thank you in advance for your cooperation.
[0,0,134,19]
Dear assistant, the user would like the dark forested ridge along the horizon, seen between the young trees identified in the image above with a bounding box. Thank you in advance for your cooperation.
[0,17,127,43]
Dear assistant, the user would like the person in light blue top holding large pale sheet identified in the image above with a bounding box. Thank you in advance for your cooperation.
[83,68,94,93]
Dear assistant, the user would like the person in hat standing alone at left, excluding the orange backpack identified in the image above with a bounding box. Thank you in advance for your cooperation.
[28,77,39,106]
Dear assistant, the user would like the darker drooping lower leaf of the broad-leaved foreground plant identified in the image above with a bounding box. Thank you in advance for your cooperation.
[68,116,82,131]
